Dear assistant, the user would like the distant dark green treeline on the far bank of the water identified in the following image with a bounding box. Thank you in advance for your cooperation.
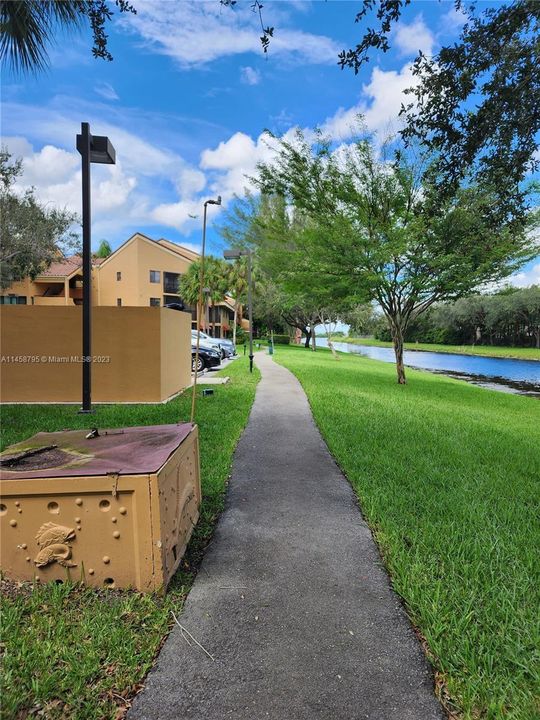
[373,285,540,347]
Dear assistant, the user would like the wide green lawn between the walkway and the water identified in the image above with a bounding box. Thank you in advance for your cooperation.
[275,347,540,720]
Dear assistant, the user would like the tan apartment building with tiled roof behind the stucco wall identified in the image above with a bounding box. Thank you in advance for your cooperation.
[0,233,240,337]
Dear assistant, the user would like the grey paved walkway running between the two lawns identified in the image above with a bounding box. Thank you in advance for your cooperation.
[128,354,445,720]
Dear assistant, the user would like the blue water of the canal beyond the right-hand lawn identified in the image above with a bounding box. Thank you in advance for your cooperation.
[317,338,540,397]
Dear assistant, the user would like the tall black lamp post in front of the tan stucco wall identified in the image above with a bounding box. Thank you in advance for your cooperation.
[77,123,116,413]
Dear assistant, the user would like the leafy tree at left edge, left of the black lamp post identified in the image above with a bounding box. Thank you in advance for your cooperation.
[0,149,79,290]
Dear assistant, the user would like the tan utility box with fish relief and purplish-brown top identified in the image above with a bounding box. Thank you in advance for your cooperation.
[0,424,201,592]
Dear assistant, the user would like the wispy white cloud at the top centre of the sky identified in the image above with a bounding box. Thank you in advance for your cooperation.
[120,0,341,68]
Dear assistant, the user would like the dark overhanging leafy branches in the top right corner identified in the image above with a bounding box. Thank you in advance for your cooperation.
[340,0,540,225]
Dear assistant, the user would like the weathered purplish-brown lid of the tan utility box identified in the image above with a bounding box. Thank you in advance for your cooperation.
[0,423,194,480]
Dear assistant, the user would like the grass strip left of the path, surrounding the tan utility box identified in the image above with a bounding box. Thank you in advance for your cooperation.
[0,357,259,720]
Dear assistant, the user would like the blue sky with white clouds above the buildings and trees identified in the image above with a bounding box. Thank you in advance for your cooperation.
[2,0,540,285]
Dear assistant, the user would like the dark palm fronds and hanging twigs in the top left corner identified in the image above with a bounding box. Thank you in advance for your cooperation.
[0,0,136,73]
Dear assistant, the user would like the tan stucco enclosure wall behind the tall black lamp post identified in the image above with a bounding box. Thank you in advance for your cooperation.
[0,305,191,402]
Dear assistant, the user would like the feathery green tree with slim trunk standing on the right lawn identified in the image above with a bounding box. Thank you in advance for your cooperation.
[257,132,535,384]
